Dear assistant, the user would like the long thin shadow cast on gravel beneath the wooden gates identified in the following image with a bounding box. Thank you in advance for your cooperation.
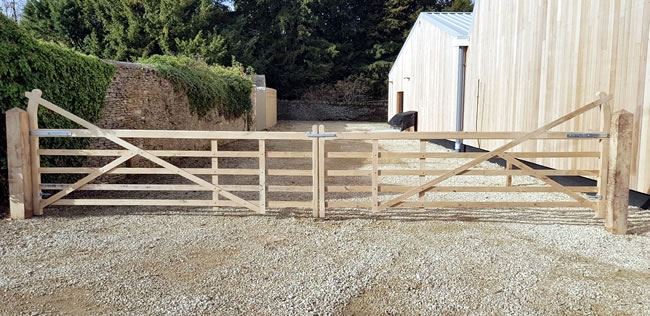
[46,207,650,234]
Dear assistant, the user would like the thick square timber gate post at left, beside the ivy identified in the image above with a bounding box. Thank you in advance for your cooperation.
[6,108,34,219]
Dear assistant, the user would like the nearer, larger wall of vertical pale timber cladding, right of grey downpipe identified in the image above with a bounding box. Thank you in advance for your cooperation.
[465,0,650,192]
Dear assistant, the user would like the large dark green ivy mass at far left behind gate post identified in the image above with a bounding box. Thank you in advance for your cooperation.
[0,14,115,209]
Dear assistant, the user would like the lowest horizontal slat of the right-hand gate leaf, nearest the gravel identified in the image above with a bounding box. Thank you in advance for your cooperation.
[327,201,584,209]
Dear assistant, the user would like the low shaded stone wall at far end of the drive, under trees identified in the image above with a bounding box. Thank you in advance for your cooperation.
[278,100,388,122]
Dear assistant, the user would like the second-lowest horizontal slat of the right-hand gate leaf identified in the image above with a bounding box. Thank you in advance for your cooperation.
[326,185,598,193]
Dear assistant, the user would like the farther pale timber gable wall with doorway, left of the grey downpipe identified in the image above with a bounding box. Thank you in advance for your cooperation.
[388,17,458,131]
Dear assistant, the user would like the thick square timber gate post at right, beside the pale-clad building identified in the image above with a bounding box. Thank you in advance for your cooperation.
[605,110,634,234]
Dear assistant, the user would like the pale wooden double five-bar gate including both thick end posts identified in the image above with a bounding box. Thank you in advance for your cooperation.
[7,90,632,233]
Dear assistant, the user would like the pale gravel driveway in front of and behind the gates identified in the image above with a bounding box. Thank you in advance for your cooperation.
[0,122,650,315]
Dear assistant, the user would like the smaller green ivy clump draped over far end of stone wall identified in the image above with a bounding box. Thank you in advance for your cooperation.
[140,55,253,119]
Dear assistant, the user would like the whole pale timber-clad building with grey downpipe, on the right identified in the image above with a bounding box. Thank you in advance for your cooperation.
[388,0,650,193]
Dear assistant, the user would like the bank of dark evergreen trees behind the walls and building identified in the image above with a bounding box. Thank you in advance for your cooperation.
[21,0,472,98]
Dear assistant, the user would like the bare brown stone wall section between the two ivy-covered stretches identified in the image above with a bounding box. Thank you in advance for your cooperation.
[93,62,246,150]
